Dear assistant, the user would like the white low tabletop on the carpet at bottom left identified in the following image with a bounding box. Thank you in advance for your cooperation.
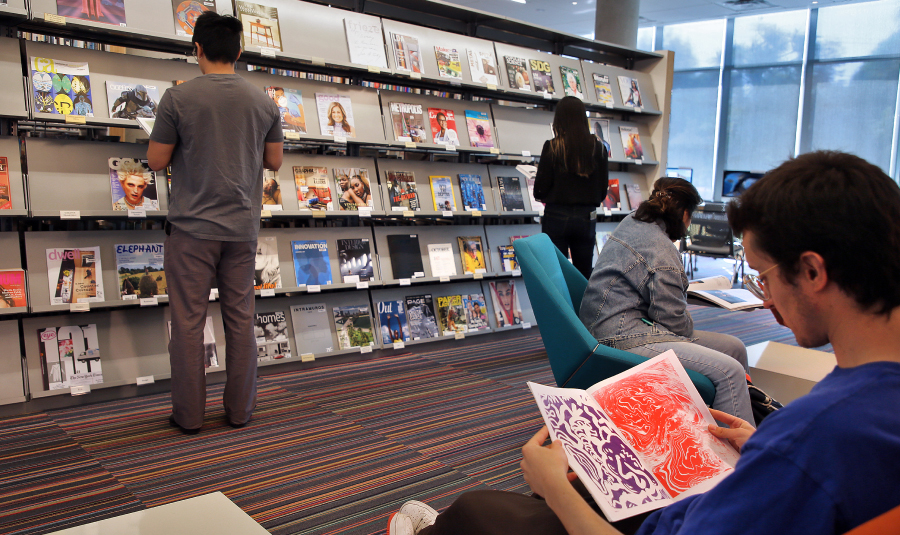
[51,492,269,535]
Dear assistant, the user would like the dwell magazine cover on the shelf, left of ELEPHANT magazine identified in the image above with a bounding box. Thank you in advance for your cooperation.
[47,247,104,305]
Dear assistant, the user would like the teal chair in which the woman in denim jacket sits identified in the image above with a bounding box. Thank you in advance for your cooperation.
[513,234,716,404]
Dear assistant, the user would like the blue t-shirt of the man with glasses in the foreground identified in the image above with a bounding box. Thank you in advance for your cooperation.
[638,362,900,535]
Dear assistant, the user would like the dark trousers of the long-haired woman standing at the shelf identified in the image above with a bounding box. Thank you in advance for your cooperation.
[541,204,597,279]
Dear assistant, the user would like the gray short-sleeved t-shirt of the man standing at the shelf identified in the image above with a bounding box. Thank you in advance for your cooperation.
[150,74,284,241]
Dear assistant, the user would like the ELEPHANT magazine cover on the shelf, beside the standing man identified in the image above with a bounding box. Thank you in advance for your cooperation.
[116,243,169,299]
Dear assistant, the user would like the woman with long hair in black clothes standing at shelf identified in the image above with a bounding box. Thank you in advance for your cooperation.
[534,97,609,278]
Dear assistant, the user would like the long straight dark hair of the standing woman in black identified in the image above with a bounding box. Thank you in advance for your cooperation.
[550,97,597,177]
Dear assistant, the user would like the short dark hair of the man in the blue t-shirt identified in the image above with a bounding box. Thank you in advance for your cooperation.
[728,151,900,314]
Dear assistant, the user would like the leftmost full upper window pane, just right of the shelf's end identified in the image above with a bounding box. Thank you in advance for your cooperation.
[657,19,725,71]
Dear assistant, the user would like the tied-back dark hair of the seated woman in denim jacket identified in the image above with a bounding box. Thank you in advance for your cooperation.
[634,176,703,241]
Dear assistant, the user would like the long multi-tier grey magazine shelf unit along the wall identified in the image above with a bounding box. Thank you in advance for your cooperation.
[0,0,673,405]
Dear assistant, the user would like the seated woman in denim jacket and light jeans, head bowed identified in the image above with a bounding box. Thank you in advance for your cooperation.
[579,177,753,422]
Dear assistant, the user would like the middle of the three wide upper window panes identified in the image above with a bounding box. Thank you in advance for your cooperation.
[734,9,807,66]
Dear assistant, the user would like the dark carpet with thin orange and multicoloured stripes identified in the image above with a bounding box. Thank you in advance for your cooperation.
[0,307,816,535]
